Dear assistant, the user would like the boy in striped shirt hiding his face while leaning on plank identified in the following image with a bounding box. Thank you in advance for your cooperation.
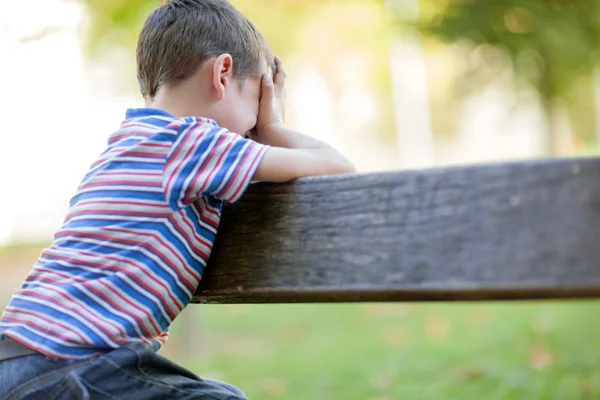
[0,0,354,399]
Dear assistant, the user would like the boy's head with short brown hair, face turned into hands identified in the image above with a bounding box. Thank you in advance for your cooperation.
[137,0,273,134]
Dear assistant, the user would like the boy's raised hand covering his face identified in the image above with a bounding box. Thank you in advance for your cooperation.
[253,56,286,142]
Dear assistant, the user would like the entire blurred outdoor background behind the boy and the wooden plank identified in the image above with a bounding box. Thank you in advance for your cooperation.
[0,0,600,400]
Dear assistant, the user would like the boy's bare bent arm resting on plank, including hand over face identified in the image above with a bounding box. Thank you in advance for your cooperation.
[252,57,356,182]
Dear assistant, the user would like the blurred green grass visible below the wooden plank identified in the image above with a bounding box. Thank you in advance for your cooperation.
[168,302,600,400]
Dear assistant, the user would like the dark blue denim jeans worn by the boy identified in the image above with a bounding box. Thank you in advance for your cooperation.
[0,335,246,400]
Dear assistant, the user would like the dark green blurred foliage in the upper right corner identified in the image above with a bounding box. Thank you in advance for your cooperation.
[422,0,600,97]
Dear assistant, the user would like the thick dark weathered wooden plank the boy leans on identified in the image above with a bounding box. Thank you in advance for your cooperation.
[192,159,600,303]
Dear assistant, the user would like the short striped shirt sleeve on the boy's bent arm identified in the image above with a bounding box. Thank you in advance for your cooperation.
[163,119,268,210]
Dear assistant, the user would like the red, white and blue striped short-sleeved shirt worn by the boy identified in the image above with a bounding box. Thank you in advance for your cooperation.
[0,108,267,359]
